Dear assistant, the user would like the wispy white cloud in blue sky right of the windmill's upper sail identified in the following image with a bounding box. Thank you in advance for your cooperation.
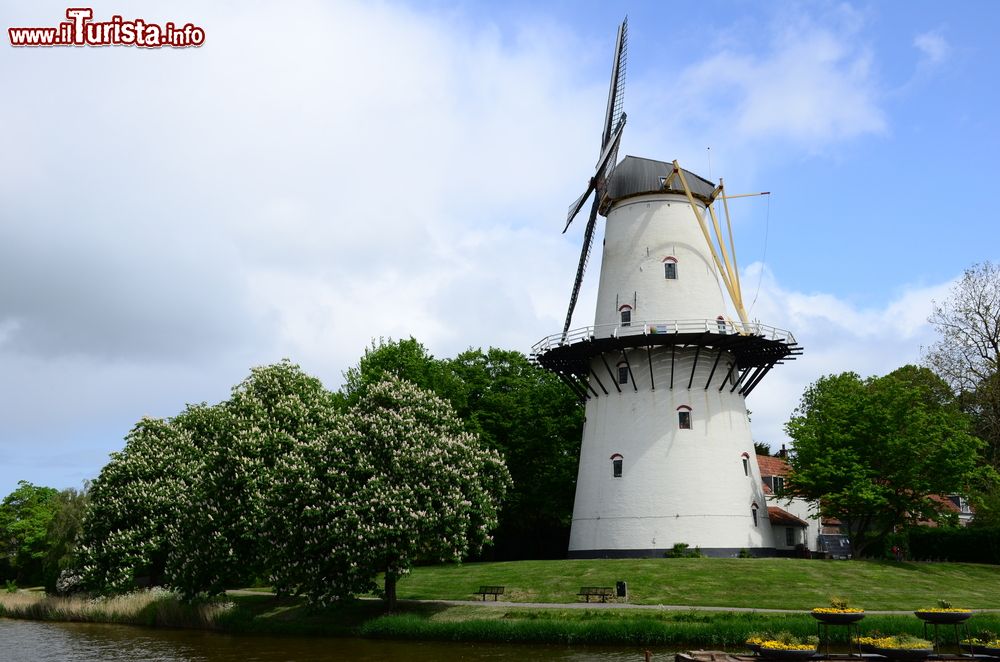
[638,9,888,161]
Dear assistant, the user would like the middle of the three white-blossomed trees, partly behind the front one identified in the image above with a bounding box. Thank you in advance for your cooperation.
[167,361,340,596]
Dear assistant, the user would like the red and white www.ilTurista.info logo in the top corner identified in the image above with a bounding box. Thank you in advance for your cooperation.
[7,7,205,48]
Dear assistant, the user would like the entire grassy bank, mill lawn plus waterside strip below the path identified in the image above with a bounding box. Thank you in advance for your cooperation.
[0,559,1000,648]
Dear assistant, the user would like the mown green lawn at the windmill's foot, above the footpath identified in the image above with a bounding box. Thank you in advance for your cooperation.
[398,558,1000,610]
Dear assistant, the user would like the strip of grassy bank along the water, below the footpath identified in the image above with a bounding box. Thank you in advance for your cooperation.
[0,591,1000,648]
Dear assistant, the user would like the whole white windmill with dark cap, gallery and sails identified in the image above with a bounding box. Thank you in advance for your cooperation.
[532,22,802,558]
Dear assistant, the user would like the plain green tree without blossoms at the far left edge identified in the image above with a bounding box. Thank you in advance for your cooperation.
[0,480,59,586]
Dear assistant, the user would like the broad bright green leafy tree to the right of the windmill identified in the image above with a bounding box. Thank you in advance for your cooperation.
[785,366,992,556]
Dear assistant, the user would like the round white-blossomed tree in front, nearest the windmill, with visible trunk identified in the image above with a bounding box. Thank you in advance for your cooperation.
[267,378,510,609]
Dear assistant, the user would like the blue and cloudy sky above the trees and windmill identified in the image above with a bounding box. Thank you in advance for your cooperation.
[0,0,1000,495]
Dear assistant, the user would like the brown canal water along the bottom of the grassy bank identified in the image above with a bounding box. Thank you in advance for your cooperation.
[0,618,673,662]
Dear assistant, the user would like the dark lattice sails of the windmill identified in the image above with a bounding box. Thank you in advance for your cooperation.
[563,17,628,336]
